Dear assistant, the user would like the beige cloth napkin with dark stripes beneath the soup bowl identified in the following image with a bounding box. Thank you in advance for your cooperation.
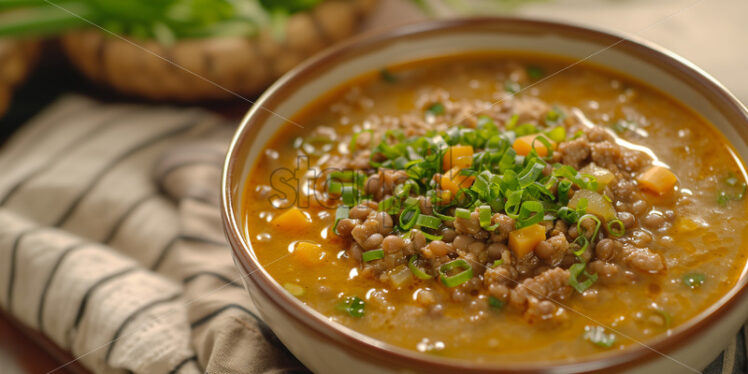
[0,96,746,374]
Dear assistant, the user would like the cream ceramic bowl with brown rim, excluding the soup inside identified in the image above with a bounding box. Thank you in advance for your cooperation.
[222,18,748,374]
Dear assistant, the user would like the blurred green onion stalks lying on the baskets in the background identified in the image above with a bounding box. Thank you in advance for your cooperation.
[0,0,322,44]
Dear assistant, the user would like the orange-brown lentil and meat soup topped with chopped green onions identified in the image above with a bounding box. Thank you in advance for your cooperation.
[242,55,748,362]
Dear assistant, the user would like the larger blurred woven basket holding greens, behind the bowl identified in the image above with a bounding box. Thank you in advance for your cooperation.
[62,0,376,102]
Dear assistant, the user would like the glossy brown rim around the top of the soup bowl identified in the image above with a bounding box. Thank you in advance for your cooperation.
[221,17,748,373]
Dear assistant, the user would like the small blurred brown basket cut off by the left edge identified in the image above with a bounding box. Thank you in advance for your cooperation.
[0,39,39,117]
